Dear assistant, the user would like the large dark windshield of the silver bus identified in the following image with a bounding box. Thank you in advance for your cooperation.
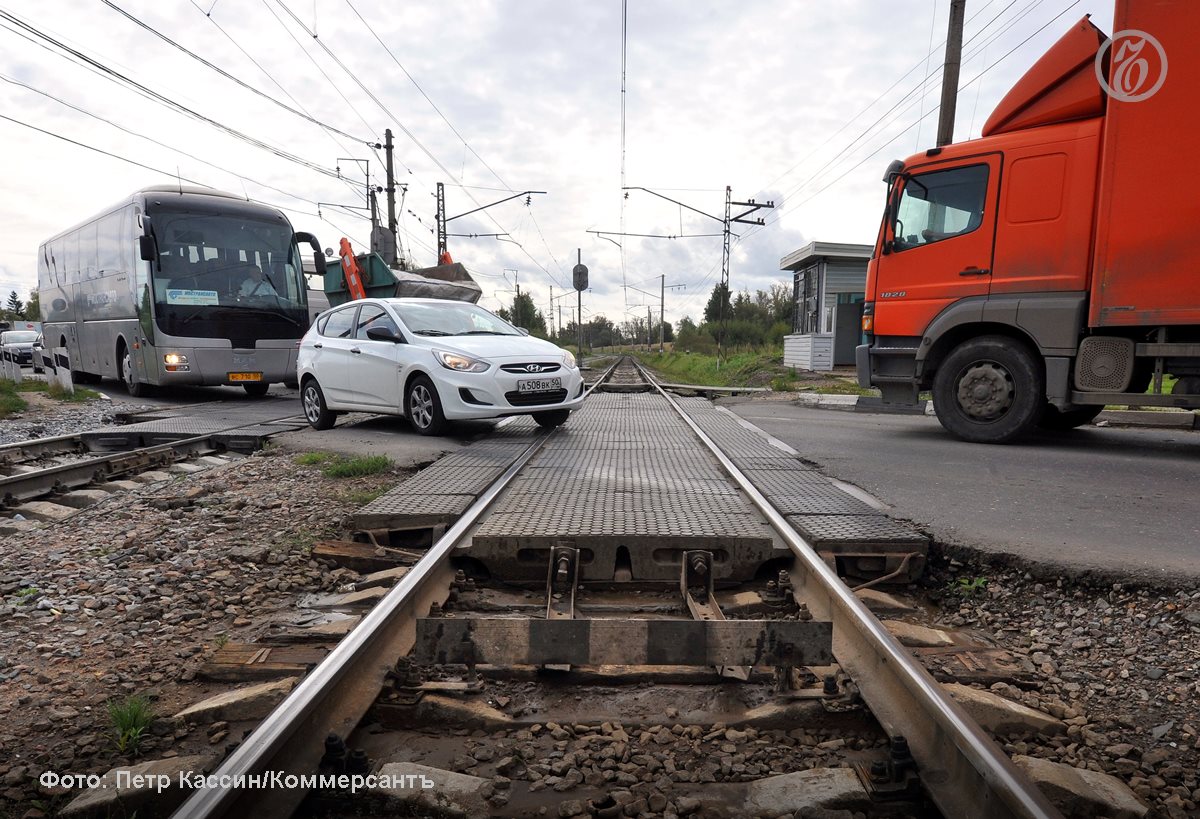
[150,209,307,337]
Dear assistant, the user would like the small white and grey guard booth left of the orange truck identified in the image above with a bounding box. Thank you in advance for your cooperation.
[779,241,871,370]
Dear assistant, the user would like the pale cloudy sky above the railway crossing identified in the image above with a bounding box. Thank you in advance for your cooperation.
[0,0,1112,323]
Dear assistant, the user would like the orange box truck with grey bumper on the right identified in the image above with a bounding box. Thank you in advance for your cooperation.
[856,0,1200,443]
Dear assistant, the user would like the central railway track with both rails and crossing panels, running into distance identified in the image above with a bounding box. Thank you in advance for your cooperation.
[176,359,1060,818]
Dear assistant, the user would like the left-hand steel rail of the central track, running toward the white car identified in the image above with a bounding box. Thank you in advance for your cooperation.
[174,430,553,819]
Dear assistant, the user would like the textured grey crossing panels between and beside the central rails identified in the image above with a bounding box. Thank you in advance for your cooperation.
[360,381,925,564]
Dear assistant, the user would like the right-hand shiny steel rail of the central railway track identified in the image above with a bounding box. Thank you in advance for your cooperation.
[630,359,1062,819]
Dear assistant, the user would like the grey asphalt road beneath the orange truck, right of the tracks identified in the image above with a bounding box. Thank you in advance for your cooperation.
[720,399,1200,584]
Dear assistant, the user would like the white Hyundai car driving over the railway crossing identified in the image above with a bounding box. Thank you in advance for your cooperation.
[296,299,583,435]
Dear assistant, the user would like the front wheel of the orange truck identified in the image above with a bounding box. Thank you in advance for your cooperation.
[934,335,1045,443]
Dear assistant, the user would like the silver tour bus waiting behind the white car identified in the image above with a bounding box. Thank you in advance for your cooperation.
[37,186,324,396]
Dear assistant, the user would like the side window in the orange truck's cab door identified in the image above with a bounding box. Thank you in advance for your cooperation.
[892,165,988,250]
